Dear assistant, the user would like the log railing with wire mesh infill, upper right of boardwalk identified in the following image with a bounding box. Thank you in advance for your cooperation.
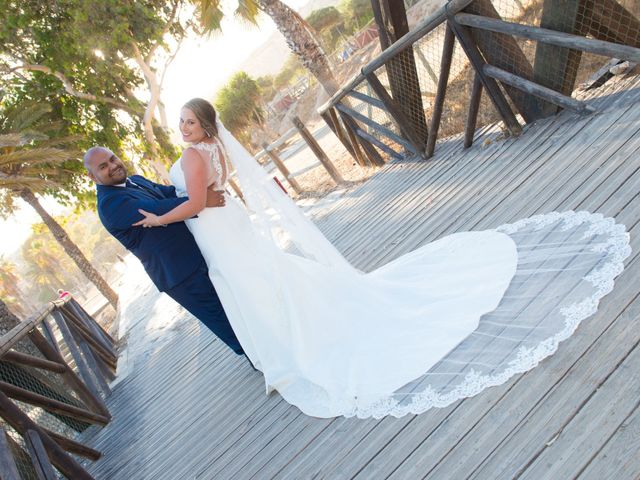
[319,0,640,165]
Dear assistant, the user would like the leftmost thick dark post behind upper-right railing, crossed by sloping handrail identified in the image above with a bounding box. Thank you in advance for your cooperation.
[371,0,429,140]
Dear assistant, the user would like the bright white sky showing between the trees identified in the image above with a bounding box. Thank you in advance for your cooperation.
[0,0,308,255]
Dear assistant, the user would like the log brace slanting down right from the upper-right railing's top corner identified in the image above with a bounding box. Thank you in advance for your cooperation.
[449,15,522,135]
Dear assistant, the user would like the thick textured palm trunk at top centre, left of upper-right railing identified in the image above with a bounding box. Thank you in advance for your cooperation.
[258,0,339,96]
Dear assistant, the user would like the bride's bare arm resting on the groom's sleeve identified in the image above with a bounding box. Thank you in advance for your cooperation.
[133,148,218,227]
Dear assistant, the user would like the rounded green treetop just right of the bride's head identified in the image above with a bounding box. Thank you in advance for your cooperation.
[214,72,264,137]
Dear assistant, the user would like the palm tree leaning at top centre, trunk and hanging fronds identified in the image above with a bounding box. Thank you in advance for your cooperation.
[193,0,338,95]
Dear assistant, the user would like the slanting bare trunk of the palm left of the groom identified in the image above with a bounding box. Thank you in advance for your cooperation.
[20,189,118,308]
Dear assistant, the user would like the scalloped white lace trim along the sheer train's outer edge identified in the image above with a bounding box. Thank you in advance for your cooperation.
[343,211,631,418]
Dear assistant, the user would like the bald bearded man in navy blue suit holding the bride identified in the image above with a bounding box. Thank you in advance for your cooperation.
[84,147,244,355]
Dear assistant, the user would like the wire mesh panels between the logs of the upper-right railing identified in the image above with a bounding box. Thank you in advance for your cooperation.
[322,0,640,160]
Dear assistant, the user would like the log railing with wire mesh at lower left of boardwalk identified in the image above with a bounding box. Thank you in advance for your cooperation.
[0,296,117,479]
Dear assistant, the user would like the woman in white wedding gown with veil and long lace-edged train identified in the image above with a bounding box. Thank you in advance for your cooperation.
[135,99,630,418]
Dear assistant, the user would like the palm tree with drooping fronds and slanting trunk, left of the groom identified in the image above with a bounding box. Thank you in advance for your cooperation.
[0,104,118,308]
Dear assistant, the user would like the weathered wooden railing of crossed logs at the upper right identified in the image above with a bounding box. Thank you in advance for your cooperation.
[319,0,640,165]
